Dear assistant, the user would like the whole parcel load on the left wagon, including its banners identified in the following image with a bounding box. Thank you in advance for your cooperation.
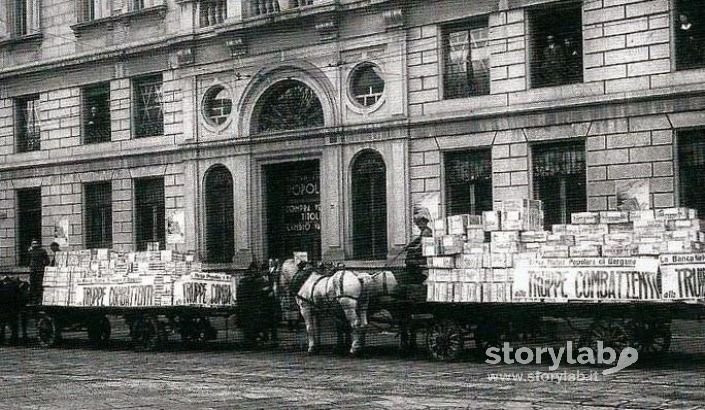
[42,249,235,307]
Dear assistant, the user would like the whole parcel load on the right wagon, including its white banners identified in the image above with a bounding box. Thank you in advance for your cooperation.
[423,199,705,302]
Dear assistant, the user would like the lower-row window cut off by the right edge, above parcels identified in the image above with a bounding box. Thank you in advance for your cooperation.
[678,129,705,217]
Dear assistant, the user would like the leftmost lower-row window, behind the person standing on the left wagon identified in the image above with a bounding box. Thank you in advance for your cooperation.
[16,188,42,266]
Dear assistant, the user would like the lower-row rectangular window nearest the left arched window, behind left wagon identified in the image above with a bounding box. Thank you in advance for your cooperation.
[134,178,166,251]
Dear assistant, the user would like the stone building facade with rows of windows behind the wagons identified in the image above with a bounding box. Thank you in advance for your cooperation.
[0,0,705,267]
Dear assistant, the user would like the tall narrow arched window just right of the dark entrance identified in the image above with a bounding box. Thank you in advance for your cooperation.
[352,150,387,259]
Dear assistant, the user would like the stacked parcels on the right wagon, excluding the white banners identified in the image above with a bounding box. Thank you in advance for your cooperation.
[423,199,705,302]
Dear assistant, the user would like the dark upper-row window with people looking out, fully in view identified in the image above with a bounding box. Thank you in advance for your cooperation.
[529,3,583,88]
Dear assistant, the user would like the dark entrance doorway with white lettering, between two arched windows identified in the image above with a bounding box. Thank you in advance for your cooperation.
[264,160,321,260]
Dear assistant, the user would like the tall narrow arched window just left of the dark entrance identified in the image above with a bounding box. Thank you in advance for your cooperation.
[205,165,235,263]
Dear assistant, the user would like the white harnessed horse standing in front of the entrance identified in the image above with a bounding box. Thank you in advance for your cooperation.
[280,259,396,355]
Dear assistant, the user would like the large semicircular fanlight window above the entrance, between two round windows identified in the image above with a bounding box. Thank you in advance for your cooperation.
[256,80,323,132]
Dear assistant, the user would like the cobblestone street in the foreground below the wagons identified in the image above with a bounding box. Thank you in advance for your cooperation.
[0,318,705,410]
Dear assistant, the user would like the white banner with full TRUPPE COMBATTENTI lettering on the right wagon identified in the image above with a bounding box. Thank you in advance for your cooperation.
[513,258,661,302]
